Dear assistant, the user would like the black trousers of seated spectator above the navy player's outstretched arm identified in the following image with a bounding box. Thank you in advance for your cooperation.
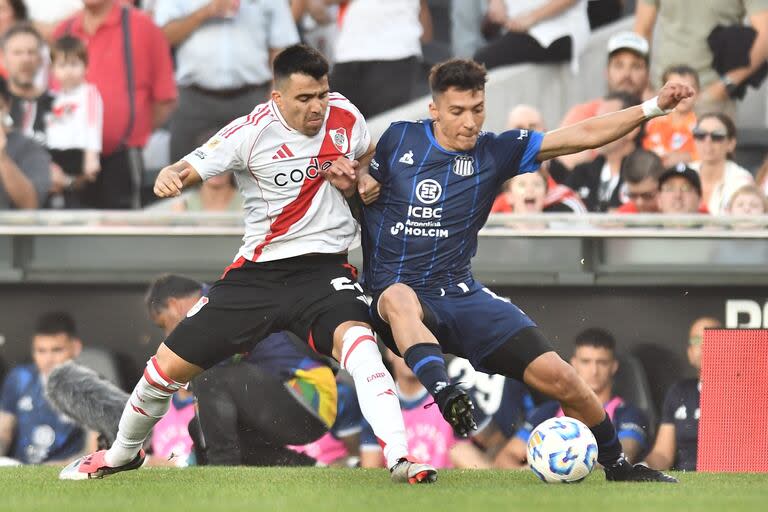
[475,32,572,69]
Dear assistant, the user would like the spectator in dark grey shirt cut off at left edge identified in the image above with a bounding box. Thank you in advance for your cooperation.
[0,77,51,210]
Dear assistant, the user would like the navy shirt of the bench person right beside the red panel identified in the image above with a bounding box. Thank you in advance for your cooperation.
[661,378,701,471]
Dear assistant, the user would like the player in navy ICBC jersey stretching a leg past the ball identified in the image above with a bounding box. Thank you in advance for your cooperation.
[326,59,693,481]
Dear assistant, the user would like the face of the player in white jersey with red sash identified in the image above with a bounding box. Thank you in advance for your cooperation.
[272,73,329,137]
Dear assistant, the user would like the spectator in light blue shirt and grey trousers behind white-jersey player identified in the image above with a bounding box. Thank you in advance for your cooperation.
[154,0,299,162]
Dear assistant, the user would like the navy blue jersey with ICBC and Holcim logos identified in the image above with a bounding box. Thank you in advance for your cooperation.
[362,121,543,293]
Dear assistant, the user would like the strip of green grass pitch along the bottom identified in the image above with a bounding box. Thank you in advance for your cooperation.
[0,467,768,512]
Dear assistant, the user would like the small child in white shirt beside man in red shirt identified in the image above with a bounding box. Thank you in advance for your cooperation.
[45,36,104,208]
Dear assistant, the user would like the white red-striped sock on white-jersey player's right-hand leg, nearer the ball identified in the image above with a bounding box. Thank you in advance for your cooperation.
[341,326,408,468]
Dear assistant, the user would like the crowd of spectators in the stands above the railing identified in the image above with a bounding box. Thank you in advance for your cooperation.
[0,0,768,218]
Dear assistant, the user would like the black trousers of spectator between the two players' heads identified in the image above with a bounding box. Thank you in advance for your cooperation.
[330,56,420,117]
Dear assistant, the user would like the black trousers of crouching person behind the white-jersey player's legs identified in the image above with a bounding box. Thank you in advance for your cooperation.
[192,362,327,466]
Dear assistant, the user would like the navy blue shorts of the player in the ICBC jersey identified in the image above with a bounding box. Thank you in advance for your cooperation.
[371,281,552,379]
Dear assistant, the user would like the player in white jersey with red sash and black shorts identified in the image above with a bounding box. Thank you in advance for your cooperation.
[60,45,437,483]
